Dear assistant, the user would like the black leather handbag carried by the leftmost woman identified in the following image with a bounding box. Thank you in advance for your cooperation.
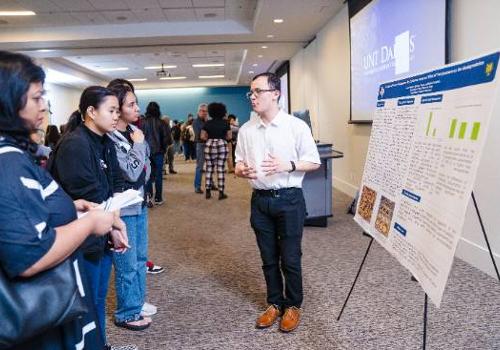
[0,258,88,349]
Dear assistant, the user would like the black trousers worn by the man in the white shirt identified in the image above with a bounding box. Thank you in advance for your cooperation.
[250,188,306,308]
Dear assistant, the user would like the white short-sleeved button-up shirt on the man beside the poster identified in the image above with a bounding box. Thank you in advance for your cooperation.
[235,110,321,190]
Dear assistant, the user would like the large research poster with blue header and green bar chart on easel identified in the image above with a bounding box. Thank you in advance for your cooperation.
[354,52,500,307]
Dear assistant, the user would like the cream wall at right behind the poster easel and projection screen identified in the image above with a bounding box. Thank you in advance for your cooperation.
[290,0,500,274]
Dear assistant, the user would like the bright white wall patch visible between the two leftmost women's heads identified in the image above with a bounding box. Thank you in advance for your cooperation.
[45,83,83,126]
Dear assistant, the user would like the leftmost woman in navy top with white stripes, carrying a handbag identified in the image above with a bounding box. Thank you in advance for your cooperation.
[0,51,124,350]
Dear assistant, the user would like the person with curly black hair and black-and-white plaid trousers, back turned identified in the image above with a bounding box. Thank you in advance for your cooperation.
[200,102,231,200]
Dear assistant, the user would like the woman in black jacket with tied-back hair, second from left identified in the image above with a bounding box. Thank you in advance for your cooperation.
[47,86,129,348]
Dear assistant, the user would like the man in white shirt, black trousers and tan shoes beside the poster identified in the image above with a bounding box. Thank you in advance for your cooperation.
[235,73,321,332]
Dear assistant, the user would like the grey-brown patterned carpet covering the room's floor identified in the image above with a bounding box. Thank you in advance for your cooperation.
[107,160,500,350]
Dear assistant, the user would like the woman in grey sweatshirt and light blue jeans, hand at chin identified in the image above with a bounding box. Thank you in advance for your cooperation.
[108,79,157,331]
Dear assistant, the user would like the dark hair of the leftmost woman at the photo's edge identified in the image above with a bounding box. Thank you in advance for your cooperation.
[0,51,45,149]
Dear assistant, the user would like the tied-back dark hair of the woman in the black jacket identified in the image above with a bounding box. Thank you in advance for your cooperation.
[64,85,116,134]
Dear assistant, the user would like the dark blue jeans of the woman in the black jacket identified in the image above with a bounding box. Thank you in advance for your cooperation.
[83,250,112,343]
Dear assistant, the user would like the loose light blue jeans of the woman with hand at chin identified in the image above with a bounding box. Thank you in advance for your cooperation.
[113,208,148,322]
